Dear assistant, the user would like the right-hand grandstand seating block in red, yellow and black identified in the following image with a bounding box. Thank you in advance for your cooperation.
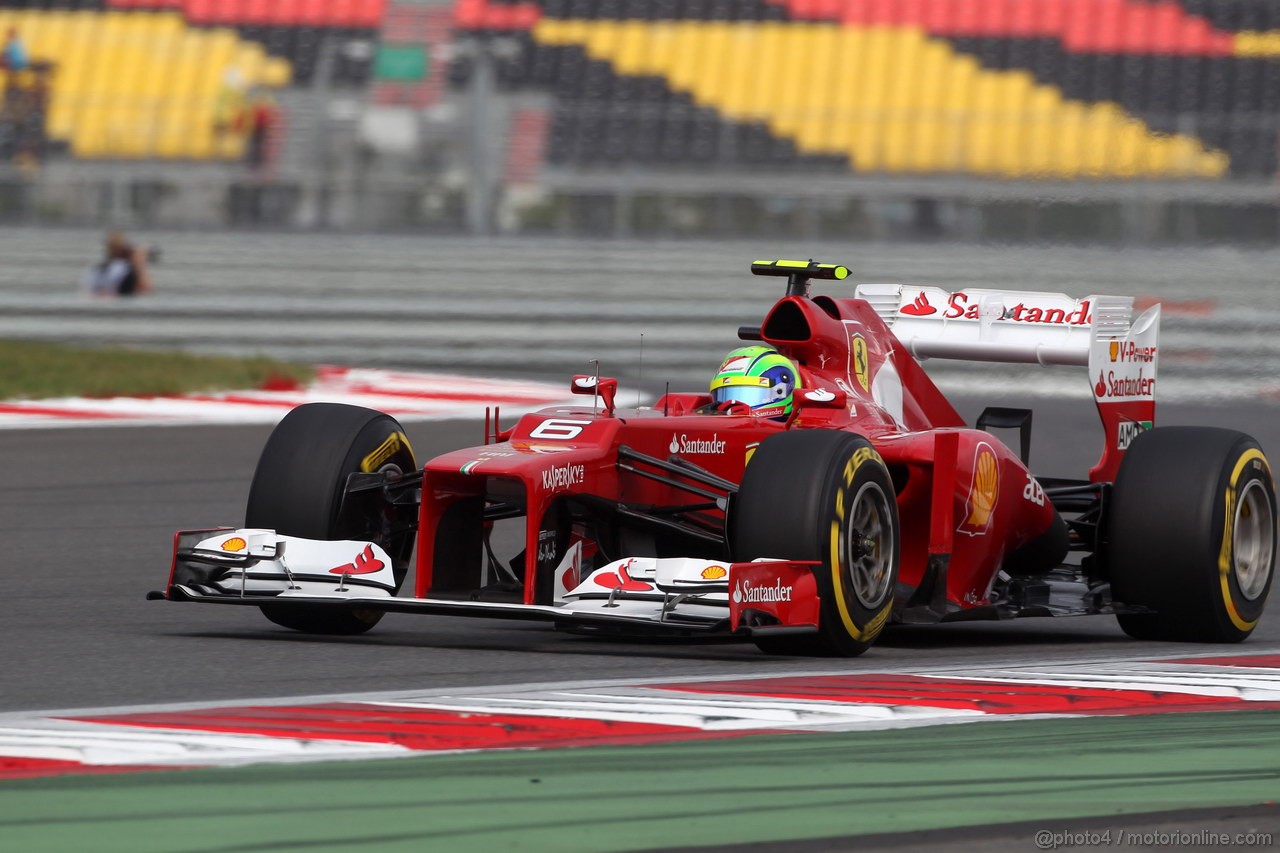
[451,0,1280,179]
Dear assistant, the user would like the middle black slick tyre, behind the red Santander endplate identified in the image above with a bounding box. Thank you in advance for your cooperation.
[730,430,899,657]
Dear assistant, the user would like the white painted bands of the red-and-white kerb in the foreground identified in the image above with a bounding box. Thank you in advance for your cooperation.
[0,654,1280,767]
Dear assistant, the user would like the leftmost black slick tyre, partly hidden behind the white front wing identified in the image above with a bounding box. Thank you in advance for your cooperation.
[244,403,417,634]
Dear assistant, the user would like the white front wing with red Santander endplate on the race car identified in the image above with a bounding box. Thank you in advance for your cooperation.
[147,528,820,637]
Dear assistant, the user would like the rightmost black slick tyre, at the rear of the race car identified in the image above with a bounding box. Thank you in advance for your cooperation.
[1107,427,1276,643]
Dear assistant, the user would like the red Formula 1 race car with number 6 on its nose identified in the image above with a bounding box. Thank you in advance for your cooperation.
[151,261,1276,656]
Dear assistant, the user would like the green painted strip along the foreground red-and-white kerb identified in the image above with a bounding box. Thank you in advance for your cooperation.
[0,711,1280,853]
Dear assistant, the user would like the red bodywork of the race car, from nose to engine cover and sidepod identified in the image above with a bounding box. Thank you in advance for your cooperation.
[415,296,1055,612]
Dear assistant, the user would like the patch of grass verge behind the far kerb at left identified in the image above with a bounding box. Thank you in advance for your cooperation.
[0,341,315,400]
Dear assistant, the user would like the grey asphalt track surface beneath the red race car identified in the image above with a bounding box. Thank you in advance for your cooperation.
[0,398,1280,711]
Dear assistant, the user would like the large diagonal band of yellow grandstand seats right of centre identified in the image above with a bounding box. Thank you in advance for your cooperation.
[524,19,1233,178]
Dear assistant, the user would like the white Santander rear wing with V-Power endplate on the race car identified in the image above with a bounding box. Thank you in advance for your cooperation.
[856,284,1160,482]
